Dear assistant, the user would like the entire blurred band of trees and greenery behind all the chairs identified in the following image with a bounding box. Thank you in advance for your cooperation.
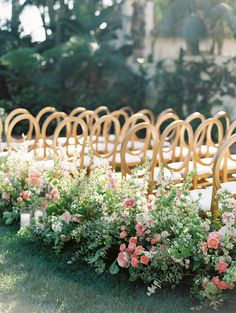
[0,0,236,116]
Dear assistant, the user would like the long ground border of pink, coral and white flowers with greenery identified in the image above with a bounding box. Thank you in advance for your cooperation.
[0,152,236,308]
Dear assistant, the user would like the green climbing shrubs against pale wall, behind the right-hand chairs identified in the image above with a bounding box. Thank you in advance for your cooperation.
[154,52,236,117]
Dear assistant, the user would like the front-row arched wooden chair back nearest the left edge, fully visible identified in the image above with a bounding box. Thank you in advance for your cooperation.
[6,114,40,151]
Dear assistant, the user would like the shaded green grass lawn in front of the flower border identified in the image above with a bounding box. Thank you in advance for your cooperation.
[0,226,236,313]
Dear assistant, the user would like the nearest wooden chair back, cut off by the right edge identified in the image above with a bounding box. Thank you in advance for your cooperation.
[211,134,236,223]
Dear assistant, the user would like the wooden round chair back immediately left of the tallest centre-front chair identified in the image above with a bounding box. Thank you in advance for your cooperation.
[89,114,120,169]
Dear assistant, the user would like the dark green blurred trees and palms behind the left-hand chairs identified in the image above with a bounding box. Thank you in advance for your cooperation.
[0,0,145,112]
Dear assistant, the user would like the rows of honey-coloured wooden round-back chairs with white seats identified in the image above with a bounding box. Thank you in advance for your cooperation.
[0,107,236,188]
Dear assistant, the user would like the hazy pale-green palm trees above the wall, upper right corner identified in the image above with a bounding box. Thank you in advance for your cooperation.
[157,0,236,55]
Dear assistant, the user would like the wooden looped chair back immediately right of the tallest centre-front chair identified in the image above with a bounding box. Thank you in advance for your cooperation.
[158,120,193,178]
